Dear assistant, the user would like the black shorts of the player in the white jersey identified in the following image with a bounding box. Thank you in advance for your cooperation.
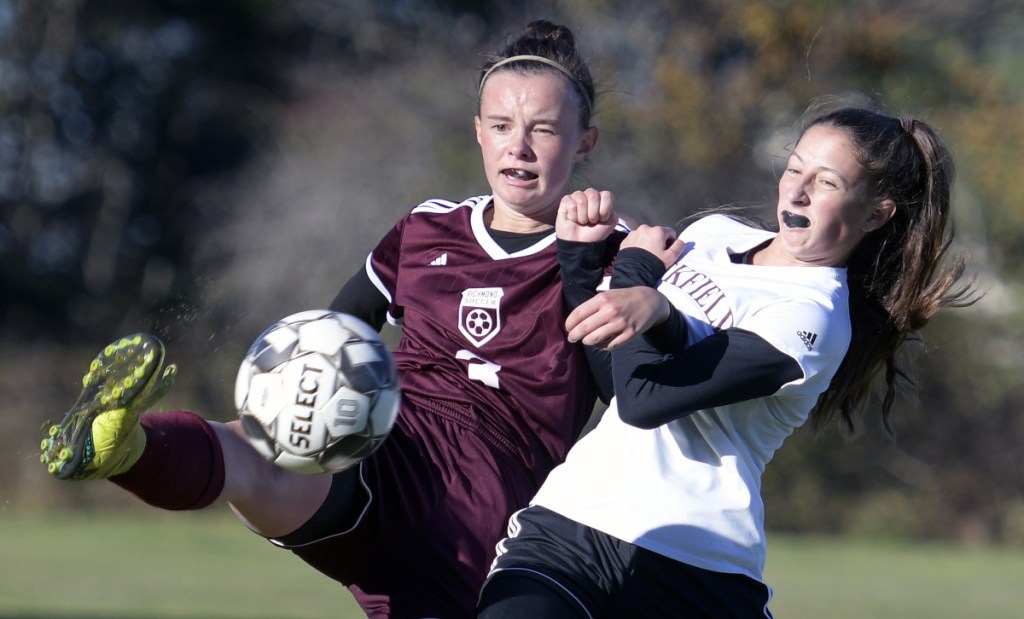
[478,506,771,619]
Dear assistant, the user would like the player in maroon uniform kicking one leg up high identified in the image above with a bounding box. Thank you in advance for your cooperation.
[37,22,622,617]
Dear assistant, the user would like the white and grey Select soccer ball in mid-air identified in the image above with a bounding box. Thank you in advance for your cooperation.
[234,310,400,473]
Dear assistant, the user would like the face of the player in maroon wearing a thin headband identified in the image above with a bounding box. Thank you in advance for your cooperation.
[475,71,597,232]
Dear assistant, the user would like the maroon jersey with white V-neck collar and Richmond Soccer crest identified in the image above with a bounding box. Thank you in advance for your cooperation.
[367,196,595,480]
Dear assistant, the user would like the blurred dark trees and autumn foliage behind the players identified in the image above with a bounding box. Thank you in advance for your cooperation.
[0,0,1024,544]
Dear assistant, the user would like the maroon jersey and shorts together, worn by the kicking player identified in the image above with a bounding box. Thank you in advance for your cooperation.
[280,196,610,619]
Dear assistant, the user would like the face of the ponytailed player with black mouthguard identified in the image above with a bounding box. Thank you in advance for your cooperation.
[771,125,893,266]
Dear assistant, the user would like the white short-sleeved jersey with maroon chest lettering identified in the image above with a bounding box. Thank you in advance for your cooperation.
[534,215,851,580]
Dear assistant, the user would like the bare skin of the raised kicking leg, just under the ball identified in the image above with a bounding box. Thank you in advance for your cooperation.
[210,421,331,537]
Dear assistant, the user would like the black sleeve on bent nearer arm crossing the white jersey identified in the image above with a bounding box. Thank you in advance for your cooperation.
[611,328,804,429]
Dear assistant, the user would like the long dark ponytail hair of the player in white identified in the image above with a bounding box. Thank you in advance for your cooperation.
[798,108,977,434]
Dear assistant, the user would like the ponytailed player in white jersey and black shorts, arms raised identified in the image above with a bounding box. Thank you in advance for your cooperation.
[478,104,972,619]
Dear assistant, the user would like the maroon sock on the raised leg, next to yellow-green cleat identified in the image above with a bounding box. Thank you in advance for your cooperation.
[111,411,224,510]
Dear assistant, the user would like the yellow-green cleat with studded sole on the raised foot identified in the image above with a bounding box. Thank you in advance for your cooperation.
[39,333,177,480]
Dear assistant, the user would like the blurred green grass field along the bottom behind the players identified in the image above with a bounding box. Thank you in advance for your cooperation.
[0,511,1024,619]
